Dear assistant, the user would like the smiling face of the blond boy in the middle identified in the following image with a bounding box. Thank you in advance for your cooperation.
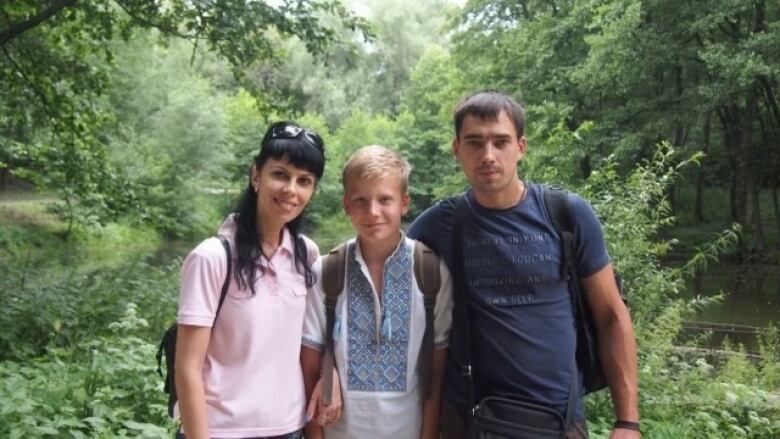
[343,176,409,244]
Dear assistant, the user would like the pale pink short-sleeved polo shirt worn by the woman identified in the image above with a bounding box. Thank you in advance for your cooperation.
[175,217,319,438]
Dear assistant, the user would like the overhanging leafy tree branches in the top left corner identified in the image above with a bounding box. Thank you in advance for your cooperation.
[0,0,365,230]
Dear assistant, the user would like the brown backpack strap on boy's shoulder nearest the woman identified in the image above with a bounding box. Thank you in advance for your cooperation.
[321,243,347,406]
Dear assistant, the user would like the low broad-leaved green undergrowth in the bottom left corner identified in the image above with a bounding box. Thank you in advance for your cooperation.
[0,303,172,438]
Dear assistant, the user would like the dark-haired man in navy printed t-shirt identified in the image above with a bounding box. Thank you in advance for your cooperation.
[409,91,640,439]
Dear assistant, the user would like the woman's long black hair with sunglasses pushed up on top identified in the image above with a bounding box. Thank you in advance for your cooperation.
[234,122,325,295]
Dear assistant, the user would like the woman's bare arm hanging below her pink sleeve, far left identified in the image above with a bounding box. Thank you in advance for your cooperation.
[174,325,211,439]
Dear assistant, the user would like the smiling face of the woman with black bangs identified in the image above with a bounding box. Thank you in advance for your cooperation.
[252,158,317,226]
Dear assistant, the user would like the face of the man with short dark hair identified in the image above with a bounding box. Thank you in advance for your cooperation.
[452,111,526,196]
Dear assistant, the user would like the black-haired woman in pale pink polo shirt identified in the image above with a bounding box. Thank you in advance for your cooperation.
[175,122,334,439]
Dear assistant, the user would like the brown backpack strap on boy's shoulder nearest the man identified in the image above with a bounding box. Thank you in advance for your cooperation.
[414,241,441,400]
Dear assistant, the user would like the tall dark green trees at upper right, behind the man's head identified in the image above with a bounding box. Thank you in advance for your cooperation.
[454,0,780,253]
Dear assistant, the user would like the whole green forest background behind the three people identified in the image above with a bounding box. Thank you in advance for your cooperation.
[0,0,780,438]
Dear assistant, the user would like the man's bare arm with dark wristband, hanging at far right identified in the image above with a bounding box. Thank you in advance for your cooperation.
[582,264,639,438]
